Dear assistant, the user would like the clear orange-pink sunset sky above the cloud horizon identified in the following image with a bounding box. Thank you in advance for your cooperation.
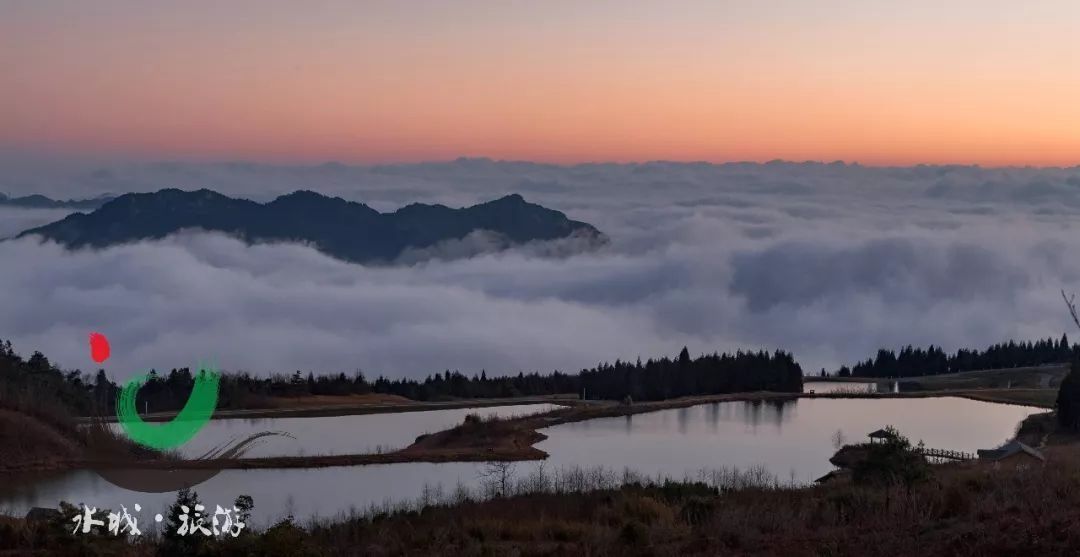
[0,0,1080,165]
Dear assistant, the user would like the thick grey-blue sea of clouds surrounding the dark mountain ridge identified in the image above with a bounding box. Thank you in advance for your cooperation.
[0,160,1080,379]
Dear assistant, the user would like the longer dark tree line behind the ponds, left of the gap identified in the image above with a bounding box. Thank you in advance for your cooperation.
[0,341,802,416]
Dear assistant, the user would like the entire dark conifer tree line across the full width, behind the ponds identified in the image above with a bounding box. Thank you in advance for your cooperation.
[0,336,1080,416]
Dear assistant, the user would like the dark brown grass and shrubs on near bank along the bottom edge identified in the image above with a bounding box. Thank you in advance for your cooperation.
[10,446,1080,556]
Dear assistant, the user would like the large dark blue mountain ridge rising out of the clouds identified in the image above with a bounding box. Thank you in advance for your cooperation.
[18,189,605,262]
